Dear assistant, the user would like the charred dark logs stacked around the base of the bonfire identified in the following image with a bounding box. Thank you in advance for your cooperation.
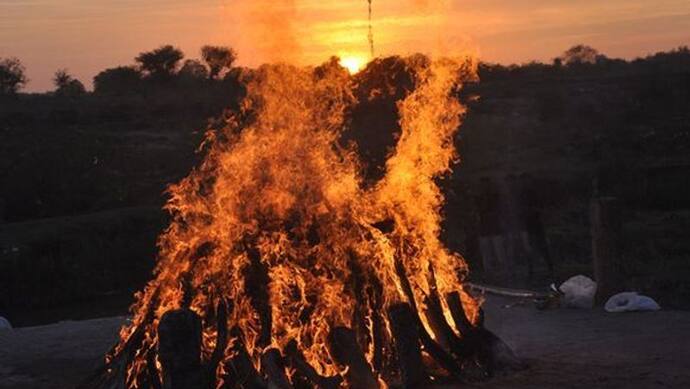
[79,263,522,389]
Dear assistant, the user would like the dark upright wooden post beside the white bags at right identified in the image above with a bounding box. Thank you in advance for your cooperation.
[590,197,624,304]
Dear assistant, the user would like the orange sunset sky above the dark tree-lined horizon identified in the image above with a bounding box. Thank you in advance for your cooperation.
[0,0,690,91]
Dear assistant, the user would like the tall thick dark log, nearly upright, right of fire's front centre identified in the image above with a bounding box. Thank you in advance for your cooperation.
[388,303,429,388]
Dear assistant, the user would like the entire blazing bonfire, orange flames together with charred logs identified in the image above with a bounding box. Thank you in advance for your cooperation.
[79,55,516,388]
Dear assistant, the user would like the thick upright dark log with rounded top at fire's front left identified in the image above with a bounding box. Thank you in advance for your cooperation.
[158,309,203,389]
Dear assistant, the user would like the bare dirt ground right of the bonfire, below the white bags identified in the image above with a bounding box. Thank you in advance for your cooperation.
[481,300,690,389]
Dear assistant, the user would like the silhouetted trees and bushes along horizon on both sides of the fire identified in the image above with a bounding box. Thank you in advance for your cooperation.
[0,45,690,97]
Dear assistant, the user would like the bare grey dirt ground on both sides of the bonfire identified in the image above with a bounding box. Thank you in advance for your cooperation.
[0,297,690,389]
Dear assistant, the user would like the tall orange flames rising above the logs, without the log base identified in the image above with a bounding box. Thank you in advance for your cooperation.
[111,55,477,387]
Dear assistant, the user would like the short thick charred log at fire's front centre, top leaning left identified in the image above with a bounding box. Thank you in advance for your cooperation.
[328,327,378,389]
